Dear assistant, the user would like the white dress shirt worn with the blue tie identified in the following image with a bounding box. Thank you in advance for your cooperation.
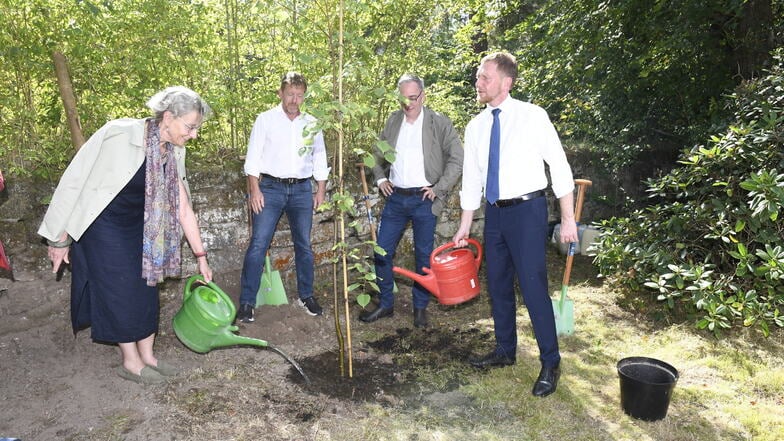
[460,96,574,210]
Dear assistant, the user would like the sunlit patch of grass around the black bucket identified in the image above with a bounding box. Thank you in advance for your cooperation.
[332,276,784,441]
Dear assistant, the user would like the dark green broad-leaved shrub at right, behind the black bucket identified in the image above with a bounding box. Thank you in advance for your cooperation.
[595,49,784,335]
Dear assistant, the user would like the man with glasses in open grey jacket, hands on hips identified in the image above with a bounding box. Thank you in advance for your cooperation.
[359,74,463,328]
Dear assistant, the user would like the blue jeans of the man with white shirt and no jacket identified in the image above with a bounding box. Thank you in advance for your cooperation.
[240,179,314,306]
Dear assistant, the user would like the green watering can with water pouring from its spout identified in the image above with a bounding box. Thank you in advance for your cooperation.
[173,275,310,384]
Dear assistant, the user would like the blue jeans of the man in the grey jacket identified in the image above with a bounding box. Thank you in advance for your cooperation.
[375,193,436,309]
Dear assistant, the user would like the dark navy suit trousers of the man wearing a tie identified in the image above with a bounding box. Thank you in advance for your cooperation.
[484,197,561,367]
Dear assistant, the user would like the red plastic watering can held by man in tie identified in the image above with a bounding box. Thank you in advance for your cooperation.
[392,239,482,305]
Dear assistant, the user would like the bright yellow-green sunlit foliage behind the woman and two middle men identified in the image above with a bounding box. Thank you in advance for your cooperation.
[0,0,474,177]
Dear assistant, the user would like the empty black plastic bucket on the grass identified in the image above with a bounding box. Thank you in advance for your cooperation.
[618,357,678,421]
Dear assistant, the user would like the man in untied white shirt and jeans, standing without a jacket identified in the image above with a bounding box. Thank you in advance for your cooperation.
[237,72,329,323]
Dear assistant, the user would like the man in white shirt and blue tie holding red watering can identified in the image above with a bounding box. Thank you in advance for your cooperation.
[453,52,577,397]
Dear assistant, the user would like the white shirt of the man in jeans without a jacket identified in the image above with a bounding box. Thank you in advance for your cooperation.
[244,104,329,181]
